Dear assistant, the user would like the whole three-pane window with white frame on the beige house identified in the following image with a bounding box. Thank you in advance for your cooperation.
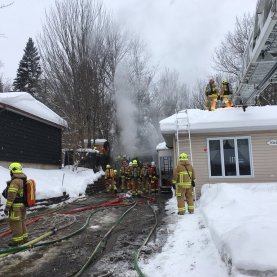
[208,137,253,178]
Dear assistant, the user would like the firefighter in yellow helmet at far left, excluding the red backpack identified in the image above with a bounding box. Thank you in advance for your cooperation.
[4,162,28,246]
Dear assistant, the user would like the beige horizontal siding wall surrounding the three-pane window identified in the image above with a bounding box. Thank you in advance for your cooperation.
[174,131,277,195]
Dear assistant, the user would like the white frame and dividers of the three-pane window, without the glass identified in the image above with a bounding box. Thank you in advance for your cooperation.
[207,136,254,179]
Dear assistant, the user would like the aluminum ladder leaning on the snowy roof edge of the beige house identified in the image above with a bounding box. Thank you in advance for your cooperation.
[176,109,197,207]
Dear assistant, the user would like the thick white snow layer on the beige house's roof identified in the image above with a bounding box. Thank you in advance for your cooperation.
[160,105,277,134]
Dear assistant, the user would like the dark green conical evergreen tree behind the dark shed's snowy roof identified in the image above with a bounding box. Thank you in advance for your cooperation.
[13,38,41,96]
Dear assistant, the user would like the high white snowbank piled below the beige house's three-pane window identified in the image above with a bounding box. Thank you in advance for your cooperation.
[201,183,277,276]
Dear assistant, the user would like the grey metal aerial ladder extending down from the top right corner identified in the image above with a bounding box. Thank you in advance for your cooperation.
[235,0,277,105]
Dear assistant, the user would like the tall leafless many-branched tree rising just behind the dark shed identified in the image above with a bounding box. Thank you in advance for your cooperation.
[39,0,125,152]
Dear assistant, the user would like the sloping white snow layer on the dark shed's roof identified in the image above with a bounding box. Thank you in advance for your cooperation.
[0,92,67,127]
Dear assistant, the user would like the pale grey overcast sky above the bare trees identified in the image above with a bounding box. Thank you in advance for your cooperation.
[0,0,257,84]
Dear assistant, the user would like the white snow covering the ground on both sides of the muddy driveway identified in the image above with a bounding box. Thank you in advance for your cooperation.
[0,166,277,277]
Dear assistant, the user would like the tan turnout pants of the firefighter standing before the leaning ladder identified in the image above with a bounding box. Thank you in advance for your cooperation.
[176,185,194,214]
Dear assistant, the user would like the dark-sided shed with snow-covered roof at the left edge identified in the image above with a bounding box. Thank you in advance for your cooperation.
[0,92,67,168]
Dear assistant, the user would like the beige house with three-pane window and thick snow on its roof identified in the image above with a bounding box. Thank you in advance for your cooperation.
[160,106,277,192]
